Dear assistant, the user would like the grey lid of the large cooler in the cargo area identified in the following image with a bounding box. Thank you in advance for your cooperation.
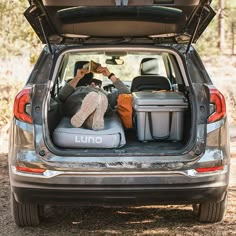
[132,91,188,106]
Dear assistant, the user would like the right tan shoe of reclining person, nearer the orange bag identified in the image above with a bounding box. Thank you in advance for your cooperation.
[85,92,108,130]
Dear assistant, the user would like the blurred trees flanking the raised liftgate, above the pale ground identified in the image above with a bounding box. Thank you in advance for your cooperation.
[0,0,236,59]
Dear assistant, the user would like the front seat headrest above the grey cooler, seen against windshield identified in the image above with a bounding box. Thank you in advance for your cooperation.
[140,58,160,75]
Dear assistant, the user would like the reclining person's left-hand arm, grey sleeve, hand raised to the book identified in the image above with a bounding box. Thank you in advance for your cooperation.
[58,69,87,102]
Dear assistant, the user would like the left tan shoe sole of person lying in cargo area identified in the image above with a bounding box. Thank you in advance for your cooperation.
[71,92,99,128]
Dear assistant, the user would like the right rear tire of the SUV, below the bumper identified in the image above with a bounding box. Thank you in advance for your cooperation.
[198,192,228,223]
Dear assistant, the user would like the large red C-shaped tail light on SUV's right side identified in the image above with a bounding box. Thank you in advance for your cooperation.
[208,88,226,123]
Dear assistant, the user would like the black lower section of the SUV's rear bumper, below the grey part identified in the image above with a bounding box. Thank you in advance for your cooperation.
[12,186,227,206]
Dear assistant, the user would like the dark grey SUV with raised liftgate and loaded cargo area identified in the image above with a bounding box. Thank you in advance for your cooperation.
[9,0,230,226]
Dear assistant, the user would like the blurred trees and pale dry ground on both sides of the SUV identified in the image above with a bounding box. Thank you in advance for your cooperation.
[0,0,236,128]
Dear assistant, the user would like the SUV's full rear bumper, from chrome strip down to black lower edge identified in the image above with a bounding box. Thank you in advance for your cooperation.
[11,168,229,205]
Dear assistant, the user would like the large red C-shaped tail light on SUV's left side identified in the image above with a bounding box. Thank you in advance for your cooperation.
[14,88,32,123]
